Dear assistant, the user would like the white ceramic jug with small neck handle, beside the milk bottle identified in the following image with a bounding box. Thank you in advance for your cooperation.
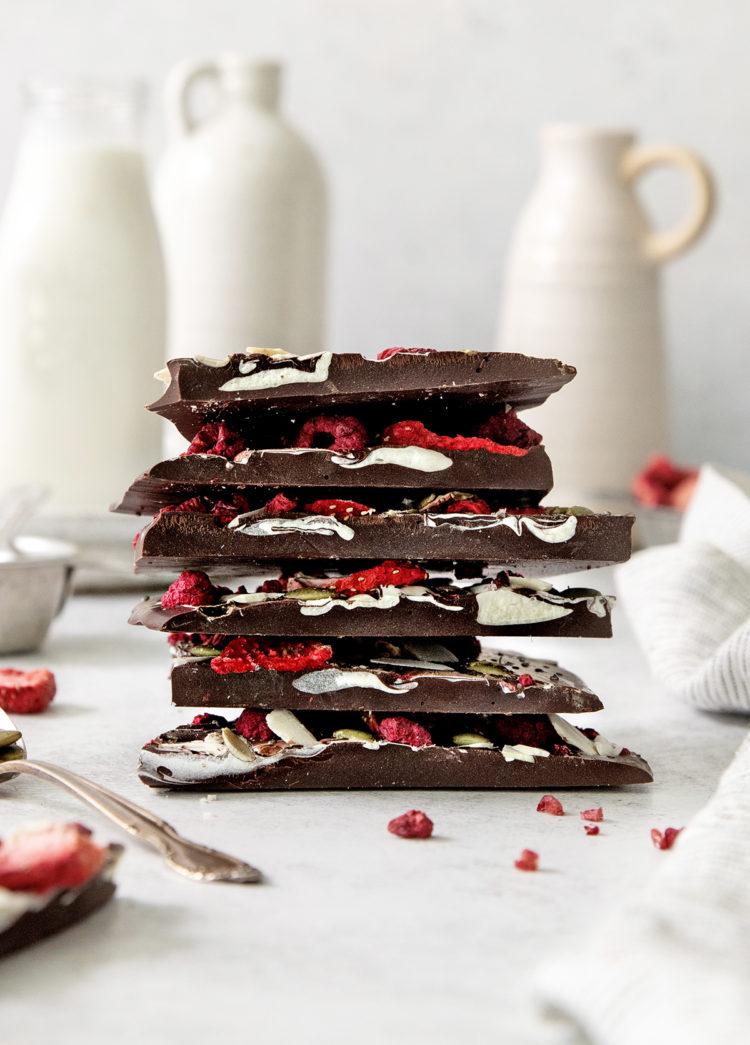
[155,54,326,367]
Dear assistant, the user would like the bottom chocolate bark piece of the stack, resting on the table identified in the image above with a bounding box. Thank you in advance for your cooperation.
[139,709,652,791]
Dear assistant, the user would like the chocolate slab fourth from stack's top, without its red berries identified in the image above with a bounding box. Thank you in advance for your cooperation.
[130,578,613,638]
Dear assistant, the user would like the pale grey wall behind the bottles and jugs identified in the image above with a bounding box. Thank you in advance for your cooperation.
[0,0,750,468]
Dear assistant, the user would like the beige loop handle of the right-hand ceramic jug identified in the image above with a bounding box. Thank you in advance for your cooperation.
[623,145,714,261]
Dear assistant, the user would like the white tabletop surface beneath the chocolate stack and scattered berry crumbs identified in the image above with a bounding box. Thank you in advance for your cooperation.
[0,575,747,1045]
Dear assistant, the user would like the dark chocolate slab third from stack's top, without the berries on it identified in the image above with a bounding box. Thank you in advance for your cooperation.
[135,510,634,576]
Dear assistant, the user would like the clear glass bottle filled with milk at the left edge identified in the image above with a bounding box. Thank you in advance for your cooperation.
[0,80,164,514]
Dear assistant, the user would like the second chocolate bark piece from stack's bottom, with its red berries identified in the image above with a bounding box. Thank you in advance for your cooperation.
[171,635,602,715]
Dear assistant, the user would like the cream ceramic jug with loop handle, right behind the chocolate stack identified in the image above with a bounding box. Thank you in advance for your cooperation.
[497,124,712,507]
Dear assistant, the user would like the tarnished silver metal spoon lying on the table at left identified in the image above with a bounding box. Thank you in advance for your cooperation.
[0,711,263,883]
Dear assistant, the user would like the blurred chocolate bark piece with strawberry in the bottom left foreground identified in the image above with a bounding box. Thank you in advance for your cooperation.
[0,823,123,956]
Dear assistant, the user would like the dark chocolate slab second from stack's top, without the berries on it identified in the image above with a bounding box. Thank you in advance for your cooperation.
[112,446,553,515]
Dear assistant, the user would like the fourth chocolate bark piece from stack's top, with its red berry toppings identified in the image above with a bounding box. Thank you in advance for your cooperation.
[130,561,614,638]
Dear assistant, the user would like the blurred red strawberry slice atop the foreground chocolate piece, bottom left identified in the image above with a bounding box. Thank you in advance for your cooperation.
[0,823,104,892]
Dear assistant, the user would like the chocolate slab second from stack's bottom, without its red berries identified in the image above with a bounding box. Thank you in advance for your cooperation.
[170,644,602,715]
